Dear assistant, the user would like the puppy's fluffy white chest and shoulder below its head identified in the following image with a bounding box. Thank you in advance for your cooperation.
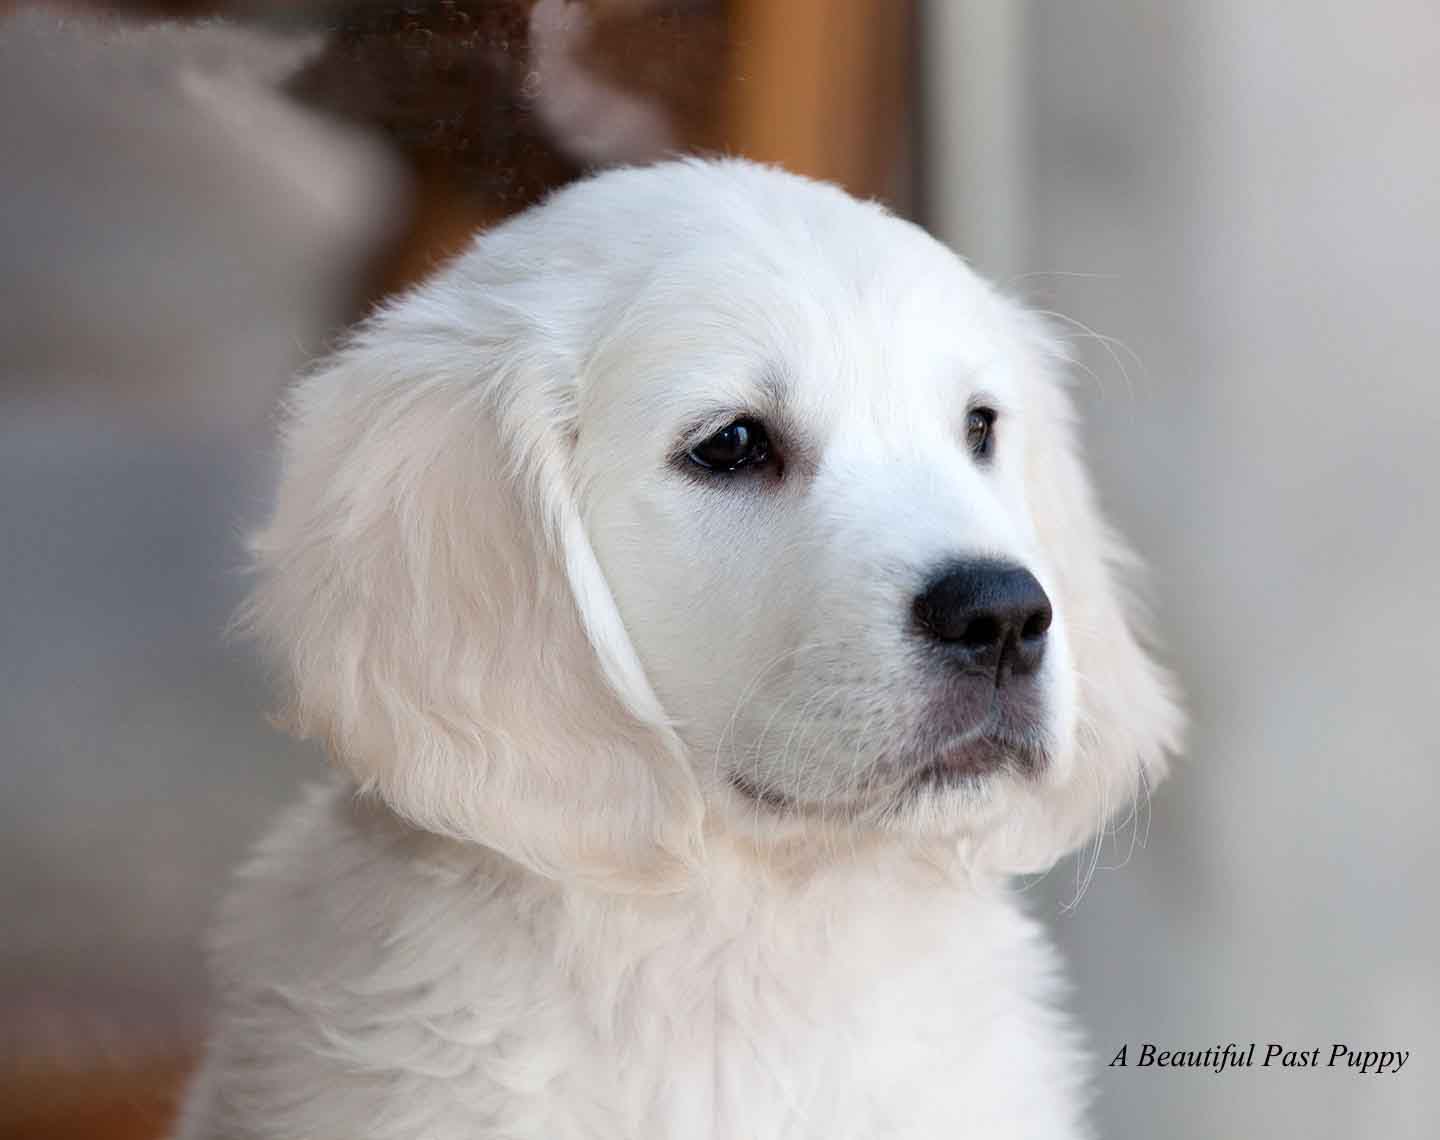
[197,811,1079,1140]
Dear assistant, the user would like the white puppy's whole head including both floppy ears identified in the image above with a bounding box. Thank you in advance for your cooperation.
[252,163,1178,875]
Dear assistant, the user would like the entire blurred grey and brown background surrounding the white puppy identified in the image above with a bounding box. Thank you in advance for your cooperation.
[0,0,1440,1140]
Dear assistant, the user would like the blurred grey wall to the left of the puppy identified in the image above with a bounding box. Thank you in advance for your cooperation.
[0,9,405,1082]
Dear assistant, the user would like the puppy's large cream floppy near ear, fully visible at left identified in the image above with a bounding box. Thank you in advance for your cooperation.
[242,266,700,885]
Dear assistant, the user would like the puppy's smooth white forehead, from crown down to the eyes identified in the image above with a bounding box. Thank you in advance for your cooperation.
[559,164,1027,446]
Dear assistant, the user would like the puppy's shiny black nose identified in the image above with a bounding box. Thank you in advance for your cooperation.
[914,561,1053,679]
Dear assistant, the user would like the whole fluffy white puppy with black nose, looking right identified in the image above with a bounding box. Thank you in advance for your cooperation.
[171,161,1179,1140]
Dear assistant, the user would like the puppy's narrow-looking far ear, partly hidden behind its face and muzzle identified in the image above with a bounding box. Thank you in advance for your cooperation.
[1002,320,1184,869]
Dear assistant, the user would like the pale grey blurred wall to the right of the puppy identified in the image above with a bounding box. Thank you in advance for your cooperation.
[926,0,1440,1140]
